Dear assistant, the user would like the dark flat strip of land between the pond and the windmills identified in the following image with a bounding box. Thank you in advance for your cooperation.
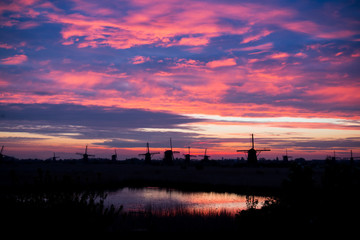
[0,161,322,195]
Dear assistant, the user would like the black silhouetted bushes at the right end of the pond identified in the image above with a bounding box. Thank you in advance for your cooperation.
[238,162,360,233]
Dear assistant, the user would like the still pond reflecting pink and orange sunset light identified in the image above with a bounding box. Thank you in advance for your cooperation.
[104,187,269,215]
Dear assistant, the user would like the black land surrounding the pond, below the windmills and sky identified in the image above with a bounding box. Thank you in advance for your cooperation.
[0,160,360,232]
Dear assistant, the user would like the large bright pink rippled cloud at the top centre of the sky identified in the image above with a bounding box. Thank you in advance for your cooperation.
[43,1,291,49]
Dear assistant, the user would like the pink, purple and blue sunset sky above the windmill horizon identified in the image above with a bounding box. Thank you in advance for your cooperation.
[0,0,360,159]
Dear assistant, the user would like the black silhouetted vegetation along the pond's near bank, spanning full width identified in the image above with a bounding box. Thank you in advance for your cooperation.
[0,162,360,233]
